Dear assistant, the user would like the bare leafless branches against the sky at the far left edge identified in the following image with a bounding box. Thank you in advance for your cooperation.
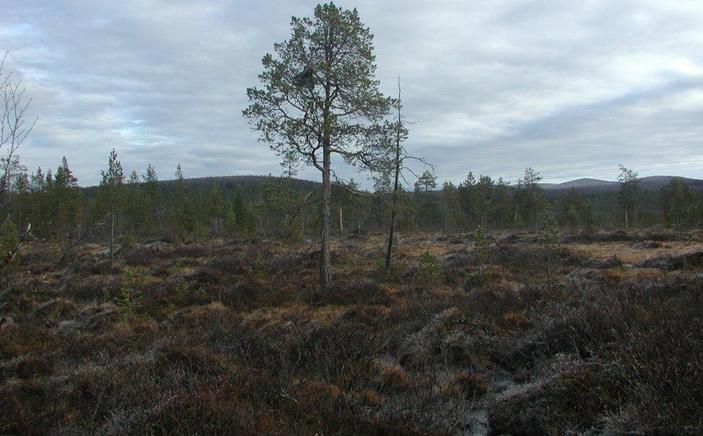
[0,52,37,202]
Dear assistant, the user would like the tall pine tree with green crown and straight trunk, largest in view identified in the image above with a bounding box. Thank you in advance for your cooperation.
[244,3,391,288]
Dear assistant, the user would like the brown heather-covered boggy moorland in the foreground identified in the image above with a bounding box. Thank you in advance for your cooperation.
[0,230,703,434]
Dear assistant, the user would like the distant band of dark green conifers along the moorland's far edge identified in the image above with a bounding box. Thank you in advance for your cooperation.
[3,150,703,247]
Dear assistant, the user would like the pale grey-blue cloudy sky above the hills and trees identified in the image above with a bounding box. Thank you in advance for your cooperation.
[0,0,703,185]
